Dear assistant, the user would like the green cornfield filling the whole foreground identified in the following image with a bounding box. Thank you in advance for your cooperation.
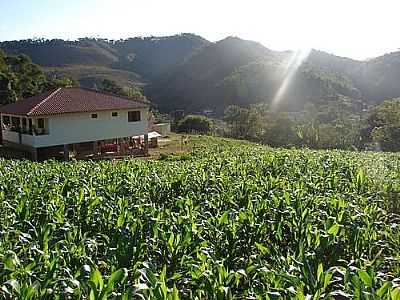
[0,138,400,300]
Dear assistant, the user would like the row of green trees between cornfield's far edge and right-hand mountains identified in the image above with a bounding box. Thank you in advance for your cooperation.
[174,98,400,151]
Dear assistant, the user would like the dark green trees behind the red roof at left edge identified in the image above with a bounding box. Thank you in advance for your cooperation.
[0,51,75,105]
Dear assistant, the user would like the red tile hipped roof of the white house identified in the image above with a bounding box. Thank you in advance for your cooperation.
[0,88,150,116]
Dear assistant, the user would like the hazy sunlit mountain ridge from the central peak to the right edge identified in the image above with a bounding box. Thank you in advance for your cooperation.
[147,42,400,113]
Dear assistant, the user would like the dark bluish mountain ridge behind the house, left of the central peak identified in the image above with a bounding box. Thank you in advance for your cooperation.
[0,34,209,87]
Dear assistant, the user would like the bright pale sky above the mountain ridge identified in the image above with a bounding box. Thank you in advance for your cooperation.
[0,0,400,59]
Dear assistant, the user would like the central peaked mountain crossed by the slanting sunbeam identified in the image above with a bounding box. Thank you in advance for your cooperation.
[147,37,361,113]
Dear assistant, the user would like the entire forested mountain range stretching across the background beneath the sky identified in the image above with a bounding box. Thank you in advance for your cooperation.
[0,34,400,112]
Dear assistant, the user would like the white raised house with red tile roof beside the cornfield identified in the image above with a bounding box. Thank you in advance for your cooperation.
[0,88,149,159]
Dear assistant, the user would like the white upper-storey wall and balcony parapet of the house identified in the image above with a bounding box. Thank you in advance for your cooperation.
[3,109,148,148]
